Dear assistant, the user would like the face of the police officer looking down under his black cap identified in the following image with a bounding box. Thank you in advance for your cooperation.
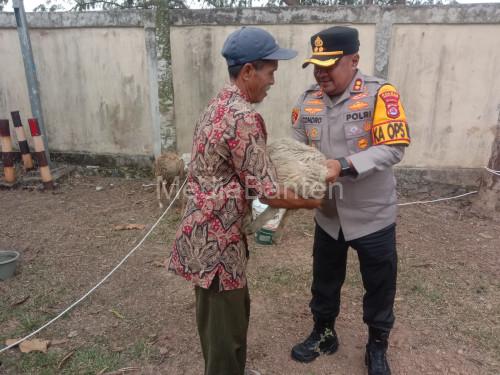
[314,53,359,96]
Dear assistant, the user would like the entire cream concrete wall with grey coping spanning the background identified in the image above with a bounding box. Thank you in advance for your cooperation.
[0,3,500,168]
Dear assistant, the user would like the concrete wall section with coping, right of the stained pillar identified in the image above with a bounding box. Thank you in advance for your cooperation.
[171,4,500,168]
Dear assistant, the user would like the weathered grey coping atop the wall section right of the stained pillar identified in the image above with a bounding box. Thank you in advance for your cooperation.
[170,3,500,26]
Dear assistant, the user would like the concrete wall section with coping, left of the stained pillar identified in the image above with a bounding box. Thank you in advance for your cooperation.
[0,12,160,166]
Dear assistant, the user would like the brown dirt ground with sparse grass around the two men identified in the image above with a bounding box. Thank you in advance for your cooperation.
[0,175,500,375]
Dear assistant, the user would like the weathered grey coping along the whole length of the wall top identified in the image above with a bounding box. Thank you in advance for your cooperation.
[0,3,500,28]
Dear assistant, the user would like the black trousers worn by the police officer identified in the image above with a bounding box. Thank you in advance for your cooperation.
[309,224,398,332]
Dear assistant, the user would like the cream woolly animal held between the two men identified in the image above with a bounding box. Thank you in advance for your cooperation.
[245,138,328,234]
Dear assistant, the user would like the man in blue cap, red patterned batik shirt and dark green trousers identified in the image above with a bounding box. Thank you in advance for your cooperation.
[169,27,320,375]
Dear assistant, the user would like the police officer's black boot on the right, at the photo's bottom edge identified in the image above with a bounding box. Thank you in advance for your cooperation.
[365,327,391,375]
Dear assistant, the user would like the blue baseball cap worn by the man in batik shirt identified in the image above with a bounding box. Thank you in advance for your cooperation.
[222,26,297,66]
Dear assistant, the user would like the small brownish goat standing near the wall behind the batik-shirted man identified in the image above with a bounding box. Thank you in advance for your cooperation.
[153,152,186,212]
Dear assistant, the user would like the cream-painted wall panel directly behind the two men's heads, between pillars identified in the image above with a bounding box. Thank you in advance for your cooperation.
[170,25,375,152]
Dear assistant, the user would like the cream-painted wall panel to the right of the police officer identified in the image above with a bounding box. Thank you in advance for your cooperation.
[389,25,500,168]
